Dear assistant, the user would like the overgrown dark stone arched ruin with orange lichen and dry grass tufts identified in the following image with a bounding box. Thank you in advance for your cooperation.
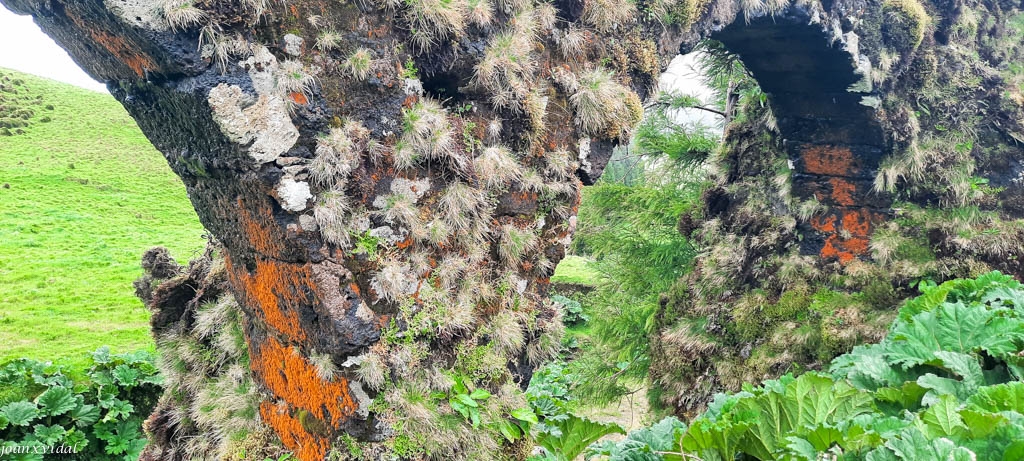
[8,0,1024,460]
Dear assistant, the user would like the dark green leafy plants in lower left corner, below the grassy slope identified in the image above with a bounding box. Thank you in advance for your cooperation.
[0,347,162,461]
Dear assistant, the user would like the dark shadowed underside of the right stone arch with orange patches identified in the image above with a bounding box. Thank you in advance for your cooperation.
[710,6,892,264]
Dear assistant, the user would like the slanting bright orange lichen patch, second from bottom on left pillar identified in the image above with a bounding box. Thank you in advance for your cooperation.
[251,336,358,428]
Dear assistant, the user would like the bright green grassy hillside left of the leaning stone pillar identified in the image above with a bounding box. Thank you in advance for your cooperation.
[0,69,204,364]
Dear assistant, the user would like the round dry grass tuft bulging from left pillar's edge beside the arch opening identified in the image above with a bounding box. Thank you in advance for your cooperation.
[569,69,643,138]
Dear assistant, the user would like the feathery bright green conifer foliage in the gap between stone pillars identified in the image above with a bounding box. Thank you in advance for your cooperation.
[572,161,702,404]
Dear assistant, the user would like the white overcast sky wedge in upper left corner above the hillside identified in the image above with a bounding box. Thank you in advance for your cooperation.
[0,6,106,92]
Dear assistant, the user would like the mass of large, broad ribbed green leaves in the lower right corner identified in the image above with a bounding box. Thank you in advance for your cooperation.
[591,273,1024,461]
